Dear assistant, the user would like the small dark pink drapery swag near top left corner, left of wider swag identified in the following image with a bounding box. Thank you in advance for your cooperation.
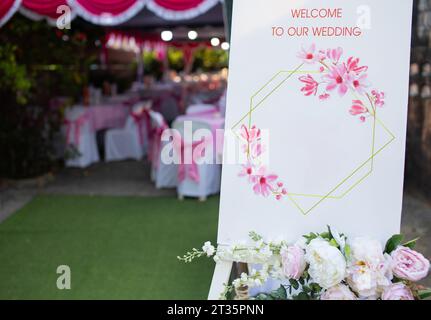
[19,0,74,25]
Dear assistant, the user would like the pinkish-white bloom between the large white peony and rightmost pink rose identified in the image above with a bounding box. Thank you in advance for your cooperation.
[347,238,393,298]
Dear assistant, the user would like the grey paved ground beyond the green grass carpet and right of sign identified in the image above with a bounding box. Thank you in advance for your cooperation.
[0,162,431,286]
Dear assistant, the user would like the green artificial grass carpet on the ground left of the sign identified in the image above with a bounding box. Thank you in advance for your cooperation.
[0,196,219,299]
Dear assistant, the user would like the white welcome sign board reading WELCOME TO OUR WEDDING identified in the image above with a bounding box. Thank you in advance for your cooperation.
[218,0,412,245]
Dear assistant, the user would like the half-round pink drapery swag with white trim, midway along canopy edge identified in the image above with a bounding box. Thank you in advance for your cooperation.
[67,0,147,25]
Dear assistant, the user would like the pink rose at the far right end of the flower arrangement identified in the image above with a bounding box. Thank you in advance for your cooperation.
[391,247,430,281]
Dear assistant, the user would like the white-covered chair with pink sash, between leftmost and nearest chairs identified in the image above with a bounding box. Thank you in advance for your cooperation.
[105,103,151,162]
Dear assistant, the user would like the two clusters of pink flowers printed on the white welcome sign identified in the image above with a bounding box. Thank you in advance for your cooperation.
[237,44,386,200]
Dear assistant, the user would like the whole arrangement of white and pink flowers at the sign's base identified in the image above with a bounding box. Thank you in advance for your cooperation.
[178,227,431,300]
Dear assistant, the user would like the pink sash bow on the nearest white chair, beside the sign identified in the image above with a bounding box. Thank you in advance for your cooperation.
[174,137,212,183]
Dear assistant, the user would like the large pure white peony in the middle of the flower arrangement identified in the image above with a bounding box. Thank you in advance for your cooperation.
[305,238,346,289]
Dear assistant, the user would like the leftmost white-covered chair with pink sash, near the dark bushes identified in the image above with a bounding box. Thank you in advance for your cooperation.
[63,107,100,168]
